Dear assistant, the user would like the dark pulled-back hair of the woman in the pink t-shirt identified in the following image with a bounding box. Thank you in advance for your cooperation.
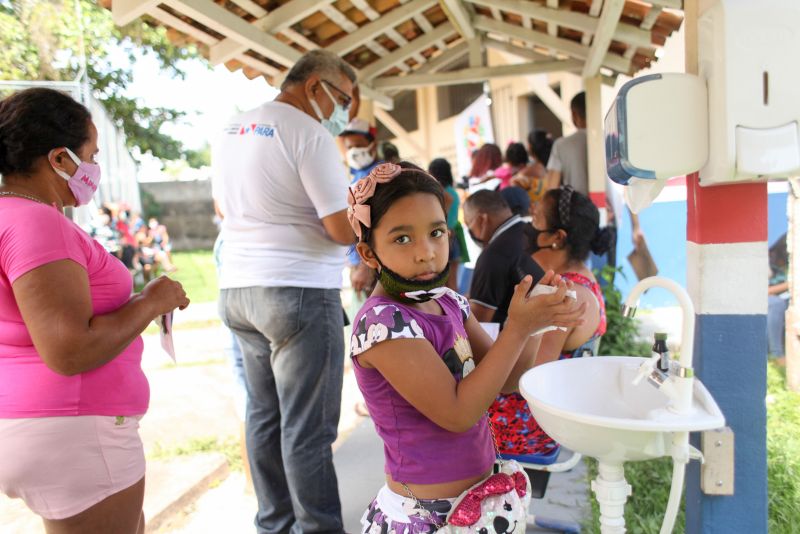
[0,88,91,175]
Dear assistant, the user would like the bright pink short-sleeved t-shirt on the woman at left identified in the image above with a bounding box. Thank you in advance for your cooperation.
[0,197,150,418]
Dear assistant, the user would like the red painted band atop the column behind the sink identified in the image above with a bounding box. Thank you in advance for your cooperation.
[686,173,768,245]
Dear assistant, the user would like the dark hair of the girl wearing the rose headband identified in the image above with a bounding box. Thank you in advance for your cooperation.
[361,161,445,243]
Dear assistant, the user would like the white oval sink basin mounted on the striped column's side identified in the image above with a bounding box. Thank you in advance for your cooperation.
[520,356,725,463]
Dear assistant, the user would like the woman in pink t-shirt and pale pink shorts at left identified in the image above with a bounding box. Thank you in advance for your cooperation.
[0,89,189,534]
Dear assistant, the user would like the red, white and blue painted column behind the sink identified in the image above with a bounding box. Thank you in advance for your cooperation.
[686,178,769,534]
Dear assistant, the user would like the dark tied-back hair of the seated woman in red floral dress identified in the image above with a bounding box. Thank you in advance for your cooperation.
[543,187,613,261]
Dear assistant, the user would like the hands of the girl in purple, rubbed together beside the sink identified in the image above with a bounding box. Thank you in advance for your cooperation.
[506,271,586,335]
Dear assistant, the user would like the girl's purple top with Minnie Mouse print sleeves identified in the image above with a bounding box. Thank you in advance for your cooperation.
[350,290,495,484]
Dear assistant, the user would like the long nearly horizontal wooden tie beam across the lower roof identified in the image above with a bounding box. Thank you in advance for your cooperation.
[373,59,583,89]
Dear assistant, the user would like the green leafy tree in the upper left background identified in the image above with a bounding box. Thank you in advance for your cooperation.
[0,0,198,160]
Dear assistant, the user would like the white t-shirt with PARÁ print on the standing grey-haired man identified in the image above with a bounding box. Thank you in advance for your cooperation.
[212,102,349,289]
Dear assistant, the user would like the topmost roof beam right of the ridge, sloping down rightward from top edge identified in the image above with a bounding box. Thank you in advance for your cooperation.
[467,0,653,48]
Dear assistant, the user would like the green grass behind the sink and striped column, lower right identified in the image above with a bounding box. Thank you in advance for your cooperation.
[584,363,800,534]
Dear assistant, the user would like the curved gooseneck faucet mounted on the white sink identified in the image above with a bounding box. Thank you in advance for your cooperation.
[622,276,694,413]
